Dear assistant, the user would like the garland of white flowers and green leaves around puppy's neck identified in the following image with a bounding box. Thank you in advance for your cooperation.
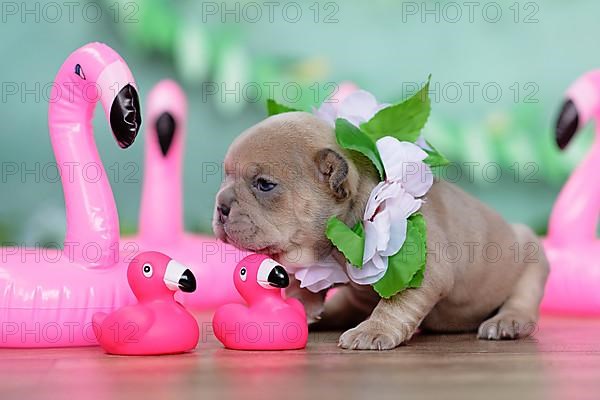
[268,77,448,298]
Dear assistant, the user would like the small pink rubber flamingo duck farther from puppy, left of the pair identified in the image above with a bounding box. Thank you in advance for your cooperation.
[94,252,200,355]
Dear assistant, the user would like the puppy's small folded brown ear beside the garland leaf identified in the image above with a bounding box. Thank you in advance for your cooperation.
[315,149,350,200]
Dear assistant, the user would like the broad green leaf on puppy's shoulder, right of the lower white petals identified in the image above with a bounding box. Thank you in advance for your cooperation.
[373,213,427,299]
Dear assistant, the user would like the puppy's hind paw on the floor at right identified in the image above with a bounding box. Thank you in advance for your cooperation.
[477,311,536,340]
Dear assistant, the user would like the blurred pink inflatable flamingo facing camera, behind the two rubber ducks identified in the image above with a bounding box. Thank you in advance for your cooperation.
[122,80,246,309]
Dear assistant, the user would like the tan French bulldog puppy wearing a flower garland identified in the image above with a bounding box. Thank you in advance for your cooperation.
[213,112,549,350]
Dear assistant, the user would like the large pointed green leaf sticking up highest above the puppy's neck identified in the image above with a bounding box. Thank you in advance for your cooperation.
[360,75,431,143]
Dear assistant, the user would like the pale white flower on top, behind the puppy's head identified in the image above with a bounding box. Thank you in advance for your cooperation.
[313,90,389,127]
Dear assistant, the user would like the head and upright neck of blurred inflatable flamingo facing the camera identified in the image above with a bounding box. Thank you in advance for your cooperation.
[140,80,187,243]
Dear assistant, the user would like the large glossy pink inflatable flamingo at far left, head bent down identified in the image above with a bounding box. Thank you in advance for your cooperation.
[0,43,141,347]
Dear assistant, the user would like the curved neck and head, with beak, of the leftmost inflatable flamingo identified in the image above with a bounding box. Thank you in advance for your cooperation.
[48,43,141,267]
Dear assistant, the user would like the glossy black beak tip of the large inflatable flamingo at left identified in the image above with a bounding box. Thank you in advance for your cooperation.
[110,84,142,149]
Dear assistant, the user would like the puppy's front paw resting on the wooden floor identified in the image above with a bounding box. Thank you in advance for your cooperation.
[338,319,410,350]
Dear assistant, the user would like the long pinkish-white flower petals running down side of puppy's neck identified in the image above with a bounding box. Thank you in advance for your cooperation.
[346,136,433,285]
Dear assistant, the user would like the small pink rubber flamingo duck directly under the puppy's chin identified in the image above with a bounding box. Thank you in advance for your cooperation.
[213,254,308,350]
